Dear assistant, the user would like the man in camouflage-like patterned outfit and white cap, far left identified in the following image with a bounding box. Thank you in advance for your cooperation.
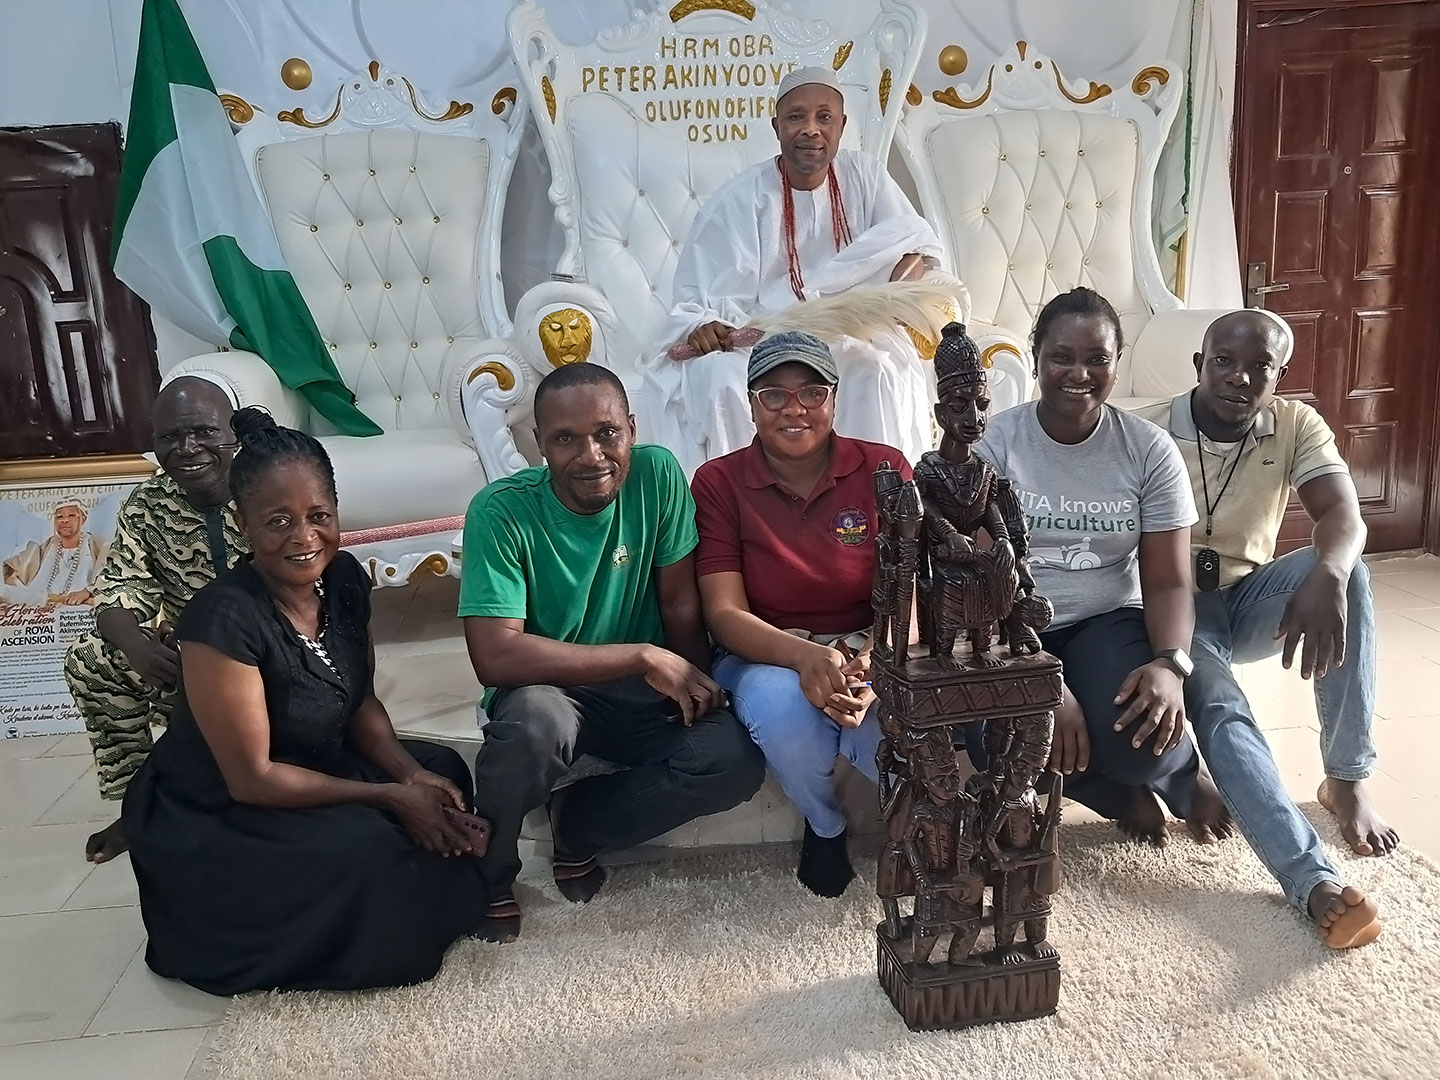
[65,376,249,863]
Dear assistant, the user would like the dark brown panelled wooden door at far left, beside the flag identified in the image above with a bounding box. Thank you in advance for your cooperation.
[0,124,158,461]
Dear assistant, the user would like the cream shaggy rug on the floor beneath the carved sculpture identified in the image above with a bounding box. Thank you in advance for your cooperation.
[203,805,1440,1080]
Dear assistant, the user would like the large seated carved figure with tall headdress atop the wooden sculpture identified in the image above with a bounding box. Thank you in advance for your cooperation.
[914,323,1048,668]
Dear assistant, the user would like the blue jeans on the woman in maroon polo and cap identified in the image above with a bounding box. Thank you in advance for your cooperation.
[714,654,881,837]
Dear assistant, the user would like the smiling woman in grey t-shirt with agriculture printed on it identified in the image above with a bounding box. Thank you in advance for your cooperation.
[976,288,1233,845]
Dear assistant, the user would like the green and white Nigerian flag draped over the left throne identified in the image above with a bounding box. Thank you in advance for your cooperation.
[111,0,380,435]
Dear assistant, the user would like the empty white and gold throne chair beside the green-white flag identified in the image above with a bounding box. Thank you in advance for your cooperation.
[166,62,601,586]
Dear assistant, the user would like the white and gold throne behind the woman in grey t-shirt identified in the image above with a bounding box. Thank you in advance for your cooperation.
[897,42,1202,408]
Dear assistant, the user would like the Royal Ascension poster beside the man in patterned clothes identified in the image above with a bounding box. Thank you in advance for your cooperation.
[0,472,148,739]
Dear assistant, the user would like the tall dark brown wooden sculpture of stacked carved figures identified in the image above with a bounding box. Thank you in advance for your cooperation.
[871,323,1061,1028]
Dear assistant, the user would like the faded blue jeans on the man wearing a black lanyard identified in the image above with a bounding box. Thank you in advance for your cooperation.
[1185,547,1375,912]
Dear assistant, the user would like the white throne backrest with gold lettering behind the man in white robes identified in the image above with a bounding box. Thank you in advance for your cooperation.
[508,0,1018,460]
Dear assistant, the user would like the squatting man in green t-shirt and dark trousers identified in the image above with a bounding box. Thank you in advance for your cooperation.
[459,364,765,937]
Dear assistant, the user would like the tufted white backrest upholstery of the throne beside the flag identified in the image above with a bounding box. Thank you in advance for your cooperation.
[256,131,490,433]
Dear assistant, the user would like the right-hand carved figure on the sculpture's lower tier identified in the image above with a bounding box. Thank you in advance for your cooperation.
[984,711,1063,963]
